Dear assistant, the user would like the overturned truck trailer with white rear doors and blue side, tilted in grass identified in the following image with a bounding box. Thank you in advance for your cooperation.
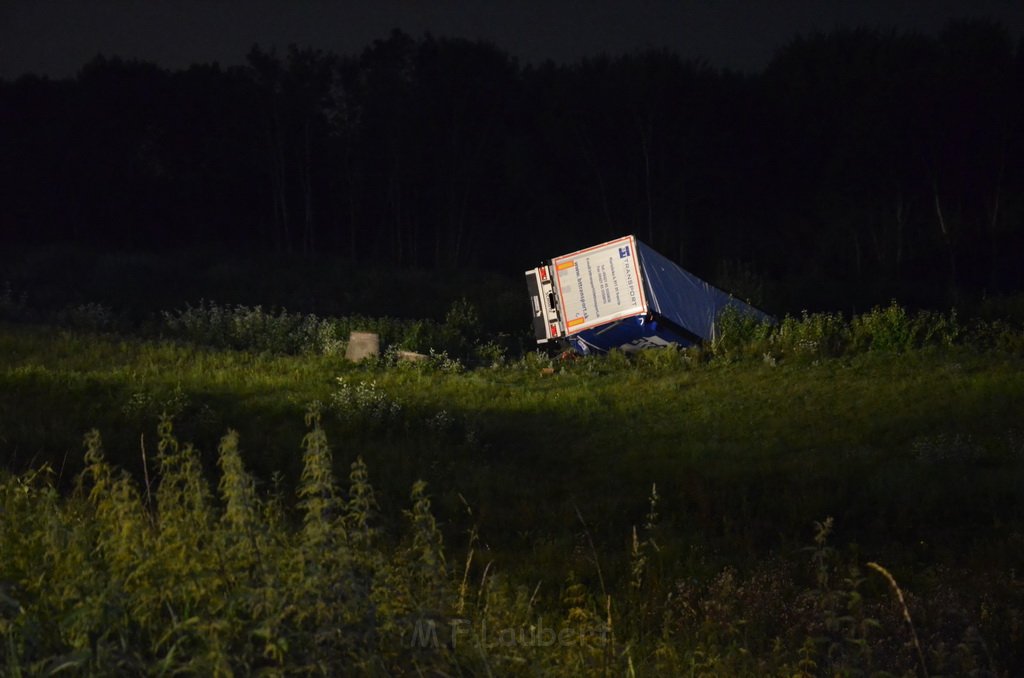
[526,236,769,353]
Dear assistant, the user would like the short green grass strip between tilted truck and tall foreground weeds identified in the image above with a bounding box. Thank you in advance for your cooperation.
[0,326,1024,561]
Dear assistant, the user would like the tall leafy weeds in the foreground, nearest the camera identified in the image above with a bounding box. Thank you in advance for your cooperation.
[0,440,1019,676]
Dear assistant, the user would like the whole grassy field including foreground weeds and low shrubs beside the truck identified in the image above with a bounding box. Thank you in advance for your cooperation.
[0,260,1024,675]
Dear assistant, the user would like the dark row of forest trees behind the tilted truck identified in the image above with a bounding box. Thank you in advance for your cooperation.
[0,20,1024,306]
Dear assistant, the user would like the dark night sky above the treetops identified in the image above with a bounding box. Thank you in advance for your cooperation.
[0,0,1024,78]
